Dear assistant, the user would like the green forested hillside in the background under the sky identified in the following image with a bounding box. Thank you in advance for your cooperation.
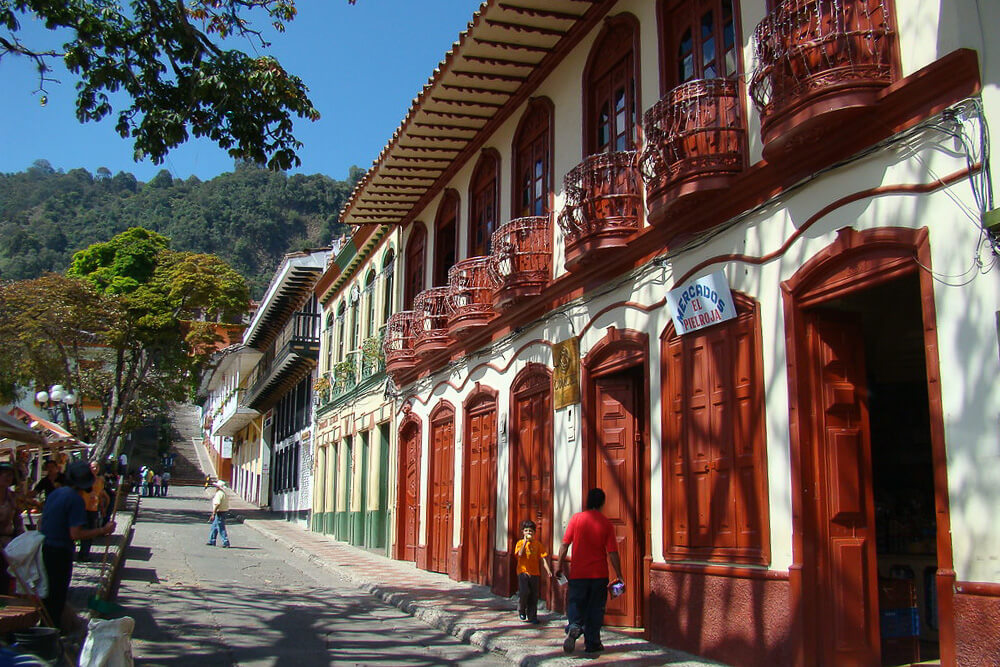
[0,160,363,298]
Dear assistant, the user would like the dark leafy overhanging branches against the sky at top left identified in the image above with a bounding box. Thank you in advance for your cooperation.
[0,0,354,169]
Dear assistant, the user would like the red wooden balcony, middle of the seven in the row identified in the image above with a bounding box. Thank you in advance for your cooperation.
[490,215,552,310]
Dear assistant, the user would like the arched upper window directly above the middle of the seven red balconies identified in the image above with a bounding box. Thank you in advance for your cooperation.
[512,99,553,218]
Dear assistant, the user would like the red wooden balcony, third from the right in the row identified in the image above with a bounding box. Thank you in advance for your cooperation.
[558,151,642,271]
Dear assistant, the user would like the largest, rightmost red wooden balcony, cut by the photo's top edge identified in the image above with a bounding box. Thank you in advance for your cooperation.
[750,0,895,161]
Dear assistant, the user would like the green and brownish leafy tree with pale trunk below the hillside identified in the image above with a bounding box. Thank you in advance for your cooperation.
[0,228,249,458]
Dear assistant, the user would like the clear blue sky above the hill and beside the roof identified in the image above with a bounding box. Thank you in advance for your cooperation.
[0,0,480,181]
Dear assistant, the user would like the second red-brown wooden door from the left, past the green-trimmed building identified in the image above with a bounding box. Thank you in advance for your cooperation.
[427,411,455,573]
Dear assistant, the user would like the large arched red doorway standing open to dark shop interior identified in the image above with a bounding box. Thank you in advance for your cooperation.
[782,228,955,665]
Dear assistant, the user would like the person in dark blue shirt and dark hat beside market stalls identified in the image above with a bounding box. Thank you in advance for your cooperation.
[39,461,115,628]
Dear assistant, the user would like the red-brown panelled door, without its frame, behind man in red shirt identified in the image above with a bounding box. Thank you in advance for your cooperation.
[590,372,644,627]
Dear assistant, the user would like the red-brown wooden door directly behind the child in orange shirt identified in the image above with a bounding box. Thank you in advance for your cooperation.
[507,373,554,604]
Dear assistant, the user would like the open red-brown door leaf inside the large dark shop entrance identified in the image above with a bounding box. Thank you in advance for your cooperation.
[804,314,880,667]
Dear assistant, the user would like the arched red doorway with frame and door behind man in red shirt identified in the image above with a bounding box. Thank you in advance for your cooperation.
[581,327,649,627]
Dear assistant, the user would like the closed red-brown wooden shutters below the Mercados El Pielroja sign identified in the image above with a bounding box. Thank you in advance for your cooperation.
[663,299,768,563]
